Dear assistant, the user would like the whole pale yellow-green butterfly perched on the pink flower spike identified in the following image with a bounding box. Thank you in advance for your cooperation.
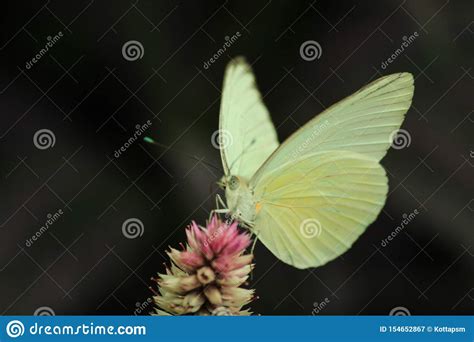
[218,57,414,269]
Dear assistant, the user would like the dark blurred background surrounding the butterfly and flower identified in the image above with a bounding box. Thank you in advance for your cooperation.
[0,0,474,315]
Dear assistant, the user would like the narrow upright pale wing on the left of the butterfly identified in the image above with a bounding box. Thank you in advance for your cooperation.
[219,57,278,181]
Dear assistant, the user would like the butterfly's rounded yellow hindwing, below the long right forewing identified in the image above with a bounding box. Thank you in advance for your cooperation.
[255,151,388,268]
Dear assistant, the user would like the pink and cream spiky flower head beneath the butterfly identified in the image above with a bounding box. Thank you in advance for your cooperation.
[154,216,254,315]
